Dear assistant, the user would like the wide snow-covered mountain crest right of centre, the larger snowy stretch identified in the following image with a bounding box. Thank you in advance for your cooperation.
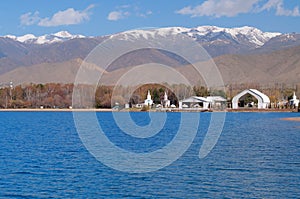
[112,26,281,48]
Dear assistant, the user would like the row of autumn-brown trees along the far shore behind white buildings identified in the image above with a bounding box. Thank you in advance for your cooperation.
[0,83,299,108]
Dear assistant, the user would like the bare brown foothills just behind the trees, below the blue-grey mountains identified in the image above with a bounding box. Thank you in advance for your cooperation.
[0,46,300,85]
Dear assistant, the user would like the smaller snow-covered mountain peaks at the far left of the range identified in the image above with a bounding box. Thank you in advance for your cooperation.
[4,31,85,44]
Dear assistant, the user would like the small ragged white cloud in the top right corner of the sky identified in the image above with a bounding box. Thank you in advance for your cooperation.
[260,0,300,17]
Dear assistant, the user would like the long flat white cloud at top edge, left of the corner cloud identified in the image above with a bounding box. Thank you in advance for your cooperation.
[176,0,259,17]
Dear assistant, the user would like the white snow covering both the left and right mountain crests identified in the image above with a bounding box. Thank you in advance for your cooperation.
[4,26,281,48]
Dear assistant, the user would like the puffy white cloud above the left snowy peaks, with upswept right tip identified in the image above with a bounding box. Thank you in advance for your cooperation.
[20,5,94,27]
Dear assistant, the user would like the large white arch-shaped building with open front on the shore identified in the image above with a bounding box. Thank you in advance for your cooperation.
[232,89,270,109]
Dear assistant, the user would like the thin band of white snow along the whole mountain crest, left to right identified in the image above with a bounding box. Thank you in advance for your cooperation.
[0,26,282,46]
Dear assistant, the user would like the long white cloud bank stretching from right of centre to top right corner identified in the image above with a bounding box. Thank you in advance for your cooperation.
[176,0,300,18]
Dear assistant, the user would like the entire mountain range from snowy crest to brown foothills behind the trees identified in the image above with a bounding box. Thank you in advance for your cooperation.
[0,26,300,84]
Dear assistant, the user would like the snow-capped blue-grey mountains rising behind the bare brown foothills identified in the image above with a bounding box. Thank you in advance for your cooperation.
[0,26,300,74]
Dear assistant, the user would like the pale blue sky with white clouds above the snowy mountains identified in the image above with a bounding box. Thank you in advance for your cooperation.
[0,0,300,36]
